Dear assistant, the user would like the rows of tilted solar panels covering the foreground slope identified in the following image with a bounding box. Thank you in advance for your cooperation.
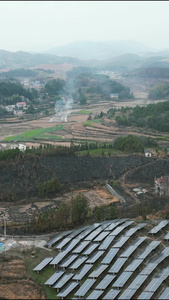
[33,219,169,300]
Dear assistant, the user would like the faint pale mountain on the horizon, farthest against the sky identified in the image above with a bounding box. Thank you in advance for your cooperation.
[47,40,156,60]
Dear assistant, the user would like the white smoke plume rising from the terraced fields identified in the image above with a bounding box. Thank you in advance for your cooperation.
[49,78,75,122]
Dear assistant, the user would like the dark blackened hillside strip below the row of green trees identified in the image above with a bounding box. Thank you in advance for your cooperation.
[0,155,156,201]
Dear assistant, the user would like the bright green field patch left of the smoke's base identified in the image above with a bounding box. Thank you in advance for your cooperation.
[4,125,65,142]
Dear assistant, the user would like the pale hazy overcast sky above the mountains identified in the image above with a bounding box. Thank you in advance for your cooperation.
[0,1,169,51]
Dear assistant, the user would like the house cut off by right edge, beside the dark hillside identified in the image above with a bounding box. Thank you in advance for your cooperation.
[155,176,169,196]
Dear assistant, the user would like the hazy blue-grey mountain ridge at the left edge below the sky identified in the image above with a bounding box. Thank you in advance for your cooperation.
[0,50,81,69]
